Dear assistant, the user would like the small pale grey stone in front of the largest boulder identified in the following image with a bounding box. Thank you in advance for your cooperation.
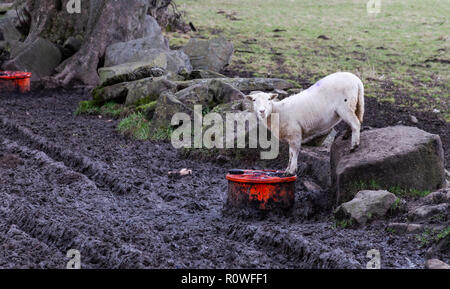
[334,190,397,225]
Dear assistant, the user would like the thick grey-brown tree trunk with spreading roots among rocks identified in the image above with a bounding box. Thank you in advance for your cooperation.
[16,0,176,85]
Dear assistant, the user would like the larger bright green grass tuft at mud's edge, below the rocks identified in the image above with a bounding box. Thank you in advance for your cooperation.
[117,112,150,140]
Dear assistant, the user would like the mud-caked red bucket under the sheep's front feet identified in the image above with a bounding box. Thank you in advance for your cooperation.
[226,170,297,210]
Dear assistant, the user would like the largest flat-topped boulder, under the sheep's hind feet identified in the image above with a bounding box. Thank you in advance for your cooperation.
[330,126,445,203]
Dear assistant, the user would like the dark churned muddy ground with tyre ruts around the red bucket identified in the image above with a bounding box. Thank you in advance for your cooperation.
[0,90,450,268]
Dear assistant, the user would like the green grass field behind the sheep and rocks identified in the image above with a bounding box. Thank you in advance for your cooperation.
[167,0,450,121]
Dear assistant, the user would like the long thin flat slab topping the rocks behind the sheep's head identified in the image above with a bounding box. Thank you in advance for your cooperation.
[176,78,294,93]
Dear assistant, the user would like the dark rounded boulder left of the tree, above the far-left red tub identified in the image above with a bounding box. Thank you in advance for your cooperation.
[4,37,62,80]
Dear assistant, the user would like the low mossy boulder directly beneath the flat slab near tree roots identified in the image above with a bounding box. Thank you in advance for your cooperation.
[93,76,176,105]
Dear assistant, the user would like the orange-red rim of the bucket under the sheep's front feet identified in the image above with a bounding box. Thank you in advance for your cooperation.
[226,170,297,184]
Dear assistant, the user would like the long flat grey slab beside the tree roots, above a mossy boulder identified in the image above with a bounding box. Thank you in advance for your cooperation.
[98,59,167,86]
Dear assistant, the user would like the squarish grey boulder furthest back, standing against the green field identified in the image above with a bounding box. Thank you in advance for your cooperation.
[183,37,234,72]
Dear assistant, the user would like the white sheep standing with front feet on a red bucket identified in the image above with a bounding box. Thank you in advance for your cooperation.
[246,72,364,174]
